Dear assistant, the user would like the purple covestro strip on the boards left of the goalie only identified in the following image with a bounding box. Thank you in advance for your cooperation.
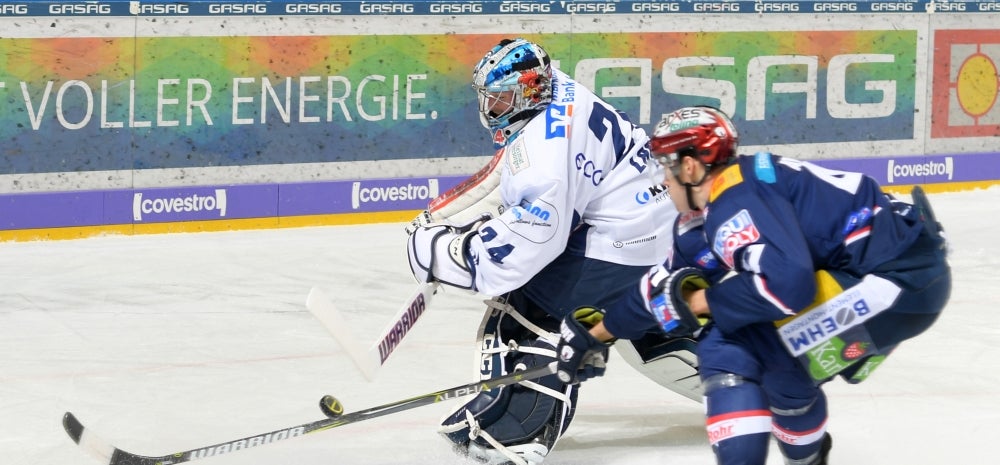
[0,176,465,230]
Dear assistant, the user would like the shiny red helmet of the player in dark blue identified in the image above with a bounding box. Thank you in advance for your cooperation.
[649,106,739,180]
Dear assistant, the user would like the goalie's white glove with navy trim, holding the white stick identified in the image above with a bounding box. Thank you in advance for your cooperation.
[406,218,485,289]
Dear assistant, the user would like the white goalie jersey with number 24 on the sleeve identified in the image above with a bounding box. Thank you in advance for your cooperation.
[429,70,676,295]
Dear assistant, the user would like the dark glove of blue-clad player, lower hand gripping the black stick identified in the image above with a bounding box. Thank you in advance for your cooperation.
[556,307,614,384]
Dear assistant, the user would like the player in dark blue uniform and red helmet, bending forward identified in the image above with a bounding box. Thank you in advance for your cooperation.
[560,107,951,465]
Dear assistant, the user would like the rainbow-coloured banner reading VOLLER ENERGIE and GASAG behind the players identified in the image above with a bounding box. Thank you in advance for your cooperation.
[0,29,920,174]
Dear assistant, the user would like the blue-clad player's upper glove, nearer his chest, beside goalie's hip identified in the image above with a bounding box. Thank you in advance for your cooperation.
[649,267,709,337]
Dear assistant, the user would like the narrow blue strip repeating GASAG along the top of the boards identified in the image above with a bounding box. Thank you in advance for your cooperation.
[0,0,1000,17]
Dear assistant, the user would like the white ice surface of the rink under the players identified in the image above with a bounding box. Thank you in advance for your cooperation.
[0,188,1000,465]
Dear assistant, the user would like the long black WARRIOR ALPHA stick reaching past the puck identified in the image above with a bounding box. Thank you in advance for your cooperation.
[63,362,558,465]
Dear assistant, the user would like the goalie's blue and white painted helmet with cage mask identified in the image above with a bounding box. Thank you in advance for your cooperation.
[472,39,552,140]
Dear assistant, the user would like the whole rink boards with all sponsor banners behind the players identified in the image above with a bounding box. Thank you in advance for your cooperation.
[0,0,1000,240]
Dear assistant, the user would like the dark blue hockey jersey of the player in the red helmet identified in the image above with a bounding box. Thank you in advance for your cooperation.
[704,153,923,331]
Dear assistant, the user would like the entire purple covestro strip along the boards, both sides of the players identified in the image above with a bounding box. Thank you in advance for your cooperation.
[0,153,1000,236]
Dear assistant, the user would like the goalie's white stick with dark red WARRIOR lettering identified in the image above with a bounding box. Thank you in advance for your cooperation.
[306,282,439,381]
